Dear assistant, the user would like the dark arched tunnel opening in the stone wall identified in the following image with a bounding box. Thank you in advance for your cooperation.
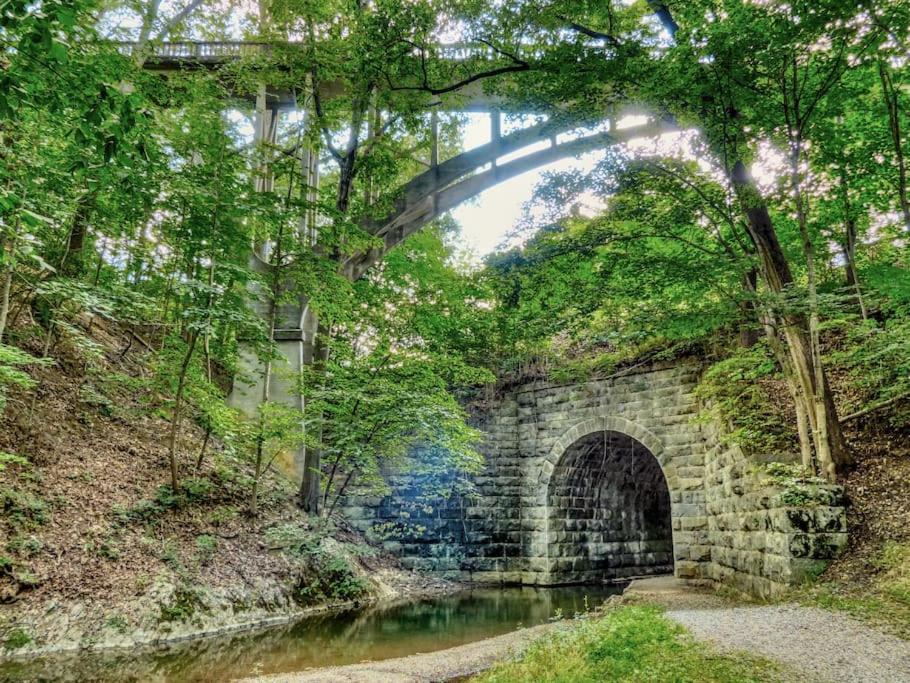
[547,431,673,583]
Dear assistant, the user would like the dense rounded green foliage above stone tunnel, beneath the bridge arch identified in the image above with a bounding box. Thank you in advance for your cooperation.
[487,160,747,376]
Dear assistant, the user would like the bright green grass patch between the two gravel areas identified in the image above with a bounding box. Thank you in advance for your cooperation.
[473,606,784,683]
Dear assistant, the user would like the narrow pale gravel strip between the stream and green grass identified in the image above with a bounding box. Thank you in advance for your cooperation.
[241,624,556,683]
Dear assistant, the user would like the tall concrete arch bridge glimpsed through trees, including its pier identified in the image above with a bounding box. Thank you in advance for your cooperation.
[130,42,675,432]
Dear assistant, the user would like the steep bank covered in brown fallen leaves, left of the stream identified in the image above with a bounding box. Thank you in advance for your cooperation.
[0,318,390,649]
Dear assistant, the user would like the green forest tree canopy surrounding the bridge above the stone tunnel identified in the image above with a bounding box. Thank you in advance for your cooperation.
[0,0,910,514]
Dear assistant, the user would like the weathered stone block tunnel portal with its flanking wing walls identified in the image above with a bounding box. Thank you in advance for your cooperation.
[344,364,846,595]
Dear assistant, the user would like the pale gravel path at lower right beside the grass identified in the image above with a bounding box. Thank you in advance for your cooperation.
[667,605,910,683]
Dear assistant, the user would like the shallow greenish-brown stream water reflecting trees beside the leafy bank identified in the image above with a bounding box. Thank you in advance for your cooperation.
[0,585,623,683]
